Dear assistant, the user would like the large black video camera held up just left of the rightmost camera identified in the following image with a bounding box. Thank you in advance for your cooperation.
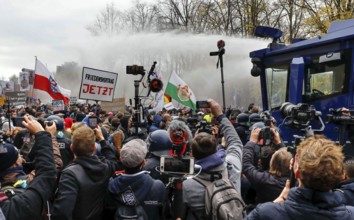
[280,102,322,128]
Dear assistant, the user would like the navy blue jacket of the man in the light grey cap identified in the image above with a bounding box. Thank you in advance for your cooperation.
[108,171,166,220]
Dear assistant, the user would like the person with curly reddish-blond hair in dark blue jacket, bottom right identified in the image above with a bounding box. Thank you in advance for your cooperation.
[246,136,354,220]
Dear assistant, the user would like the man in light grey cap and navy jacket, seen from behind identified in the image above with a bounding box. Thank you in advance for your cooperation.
[106,139,166,220]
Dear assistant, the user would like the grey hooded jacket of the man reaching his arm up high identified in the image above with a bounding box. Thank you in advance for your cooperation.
[181,117,242,219]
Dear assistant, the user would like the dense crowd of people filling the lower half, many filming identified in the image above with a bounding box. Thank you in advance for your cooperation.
[0,99,354,220]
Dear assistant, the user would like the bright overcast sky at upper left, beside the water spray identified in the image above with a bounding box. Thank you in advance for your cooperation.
[0,0,137,79]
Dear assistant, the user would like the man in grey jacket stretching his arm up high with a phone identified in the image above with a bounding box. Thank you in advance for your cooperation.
[181,99,242,219]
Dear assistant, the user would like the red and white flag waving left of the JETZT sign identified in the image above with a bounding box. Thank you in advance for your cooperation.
[33,59,71,104]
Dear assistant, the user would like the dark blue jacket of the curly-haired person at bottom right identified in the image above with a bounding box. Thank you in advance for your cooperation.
[246,187,354,220]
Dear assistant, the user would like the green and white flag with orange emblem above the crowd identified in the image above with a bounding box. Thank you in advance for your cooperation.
[165,72,196,110]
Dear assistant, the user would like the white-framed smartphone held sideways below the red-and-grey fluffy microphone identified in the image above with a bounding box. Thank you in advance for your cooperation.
[160,156,194,174]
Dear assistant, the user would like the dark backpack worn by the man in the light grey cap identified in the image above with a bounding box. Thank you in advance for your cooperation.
[114,187,148,220]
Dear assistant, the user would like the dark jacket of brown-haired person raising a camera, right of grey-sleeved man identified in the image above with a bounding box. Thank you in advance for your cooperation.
[242,141,289,203]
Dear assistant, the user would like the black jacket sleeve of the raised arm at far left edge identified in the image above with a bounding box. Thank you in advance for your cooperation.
[0,131,56,220]
